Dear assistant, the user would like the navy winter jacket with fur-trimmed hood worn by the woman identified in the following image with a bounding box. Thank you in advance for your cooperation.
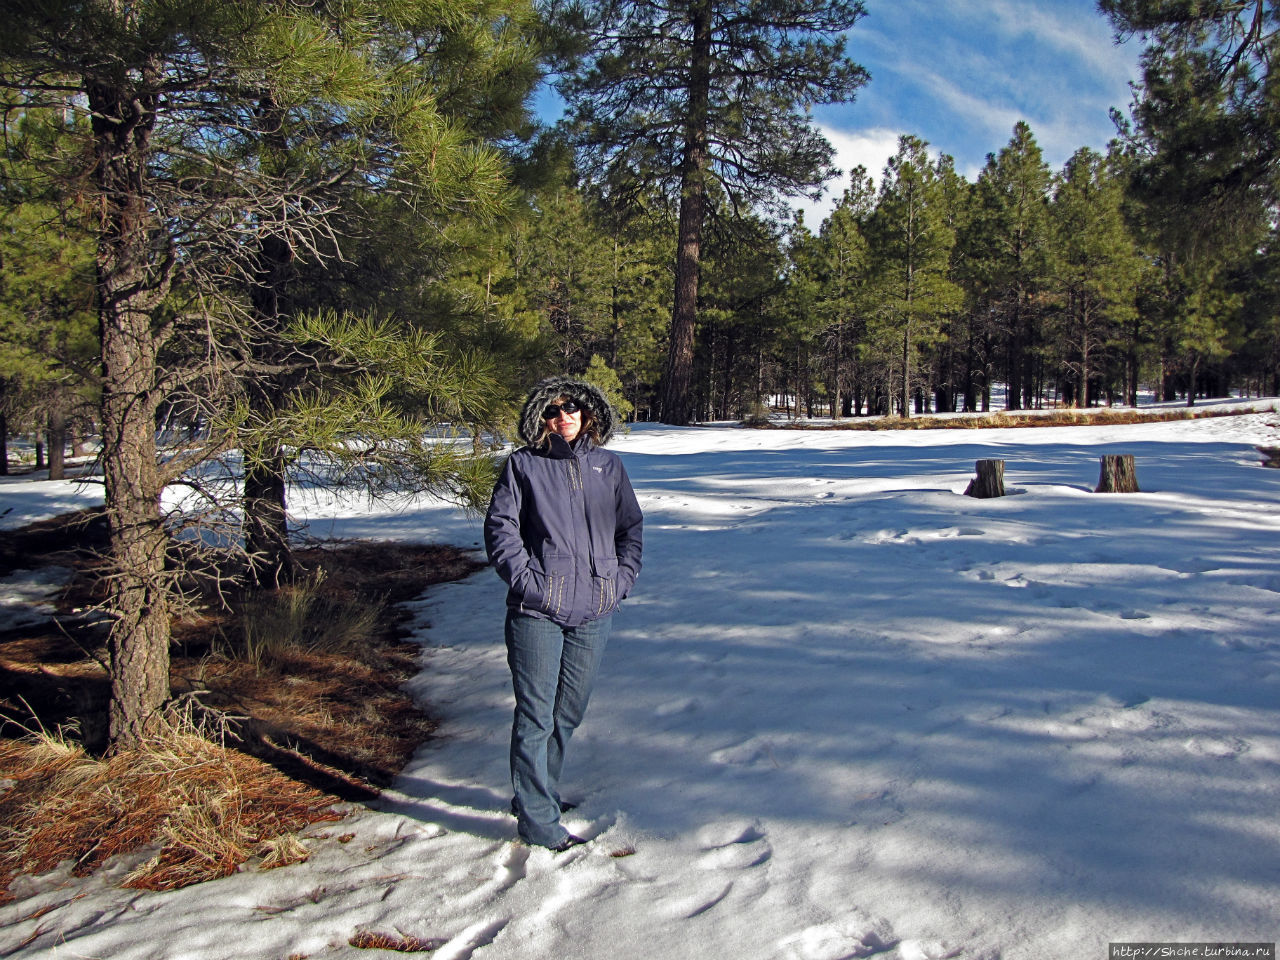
[484,380,643,627]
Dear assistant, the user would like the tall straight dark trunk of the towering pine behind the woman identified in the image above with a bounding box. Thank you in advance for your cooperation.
[662,0,712,426]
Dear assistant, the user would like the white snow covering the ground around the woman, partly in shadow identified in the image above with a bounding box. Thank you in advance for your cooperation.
[0,403,1280,960]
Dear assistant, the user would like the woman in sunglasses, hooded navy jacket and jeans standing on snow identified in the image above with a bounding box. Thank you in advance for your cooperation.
[484,378,641,852]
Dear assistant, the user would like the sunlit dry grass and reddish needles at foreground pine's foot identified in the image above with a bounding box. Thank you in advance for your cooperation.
[0,721,340,890]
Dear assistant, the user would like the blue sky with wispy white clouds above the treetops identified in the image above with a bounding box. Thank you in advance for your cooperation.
[805,0,1142,221]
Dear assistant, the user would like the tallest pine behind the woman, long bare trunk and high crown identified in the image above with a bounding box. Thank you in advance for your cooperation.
[559,0,867,424]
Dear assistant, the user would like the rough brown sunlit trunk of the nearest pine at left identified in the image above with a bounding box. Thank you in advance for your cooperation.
[88,65,170,749]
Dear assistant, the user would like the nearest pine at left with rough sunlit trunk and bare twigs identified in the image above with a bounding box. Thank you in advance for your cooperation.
[0,0,540,746]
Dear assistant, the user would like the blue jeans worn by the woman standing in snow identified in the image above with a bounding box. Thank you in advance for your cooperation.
[506,611,612,846]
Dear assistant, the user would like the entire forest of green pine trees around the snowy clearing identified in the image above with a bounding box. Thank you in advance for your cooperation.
[0,0,1280,744]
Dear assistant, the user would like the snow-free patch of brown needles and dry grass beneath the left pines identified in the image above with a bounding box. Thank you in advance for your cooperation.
[0,524,477,900]
